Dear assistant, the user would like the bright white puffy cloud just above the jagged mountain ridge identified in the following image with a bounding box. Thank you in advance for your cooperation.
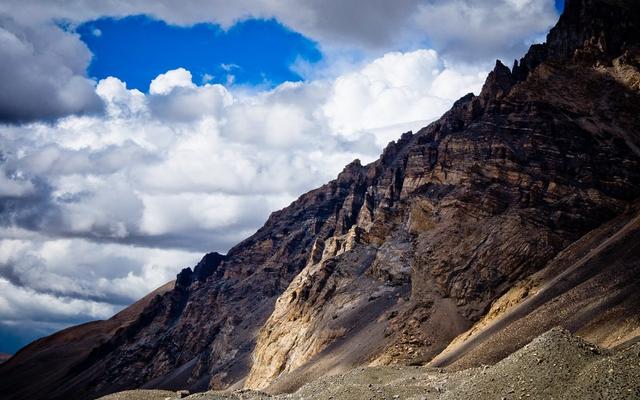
[323,50,485,145]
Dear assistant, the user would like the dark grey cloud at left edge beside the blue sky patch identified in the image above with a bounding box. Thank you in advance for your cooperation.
[0,13,102,122]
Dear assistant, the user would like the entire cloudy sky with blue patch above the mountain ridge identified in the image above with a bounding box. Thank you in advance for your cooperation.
[0,0,562,353]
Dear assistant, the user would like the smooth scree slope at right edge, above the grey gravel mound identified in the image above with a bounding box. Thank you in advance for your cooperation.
[431,198,640,369]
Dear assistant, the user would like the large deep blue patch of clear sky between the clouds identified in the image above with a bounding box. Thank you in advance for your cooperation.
[77,15,322,92]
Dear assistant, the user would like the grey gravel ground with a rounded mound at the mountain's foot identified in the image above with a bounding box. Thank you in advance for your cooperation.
[101,328,640,400]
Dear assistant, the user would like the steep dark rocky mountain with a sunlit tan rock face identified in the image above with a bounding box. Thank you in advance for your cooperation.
[0,0,640,399]
